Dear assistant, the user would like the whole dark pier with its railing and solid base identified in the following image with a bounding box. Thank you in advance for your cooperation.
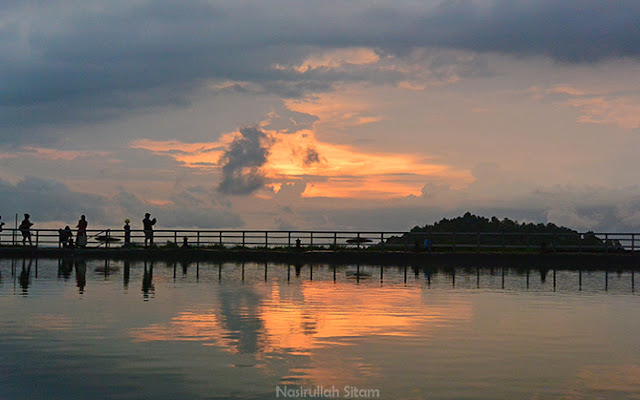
[0,229,640,269]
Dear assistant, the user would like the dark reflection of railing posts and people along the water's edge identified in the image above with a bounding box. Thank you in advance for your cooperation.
[0,258,636,300]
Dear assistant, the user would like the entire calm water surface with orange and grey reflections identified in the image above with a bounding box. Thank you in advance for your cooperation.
[0,260,640,400]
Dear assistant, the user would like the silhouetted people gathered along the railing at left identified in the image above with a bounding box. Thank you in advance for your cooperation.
[0,213,156,248]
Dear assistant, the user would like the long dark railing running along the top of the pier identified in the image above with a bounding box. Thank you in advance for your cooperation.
[0,228,640,253]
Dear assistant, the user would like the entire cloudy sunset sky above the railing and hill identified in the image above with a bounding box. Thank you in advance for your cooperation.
[0,0,640,232]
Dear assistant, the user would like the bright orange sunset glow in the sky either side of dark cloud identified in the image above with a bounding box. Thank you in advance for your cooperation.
[131,130,472,198]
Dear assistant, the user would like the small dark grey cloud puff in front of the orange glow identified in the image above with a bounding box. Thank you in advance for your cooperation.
[218,127,271,195]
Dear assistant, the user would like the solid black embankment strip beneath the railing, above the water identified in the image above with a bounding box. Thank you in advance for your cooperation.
[0,247,640,270]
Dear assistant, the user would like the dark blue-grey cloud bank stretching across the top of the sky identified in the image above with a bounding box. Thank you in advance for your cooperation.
[0,0,640,136]
